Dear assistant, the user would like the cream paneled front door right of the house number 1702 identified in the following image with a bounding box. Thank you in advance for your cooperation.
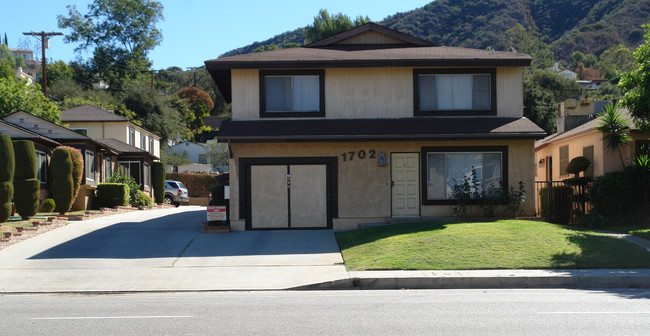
[390,153,420,217]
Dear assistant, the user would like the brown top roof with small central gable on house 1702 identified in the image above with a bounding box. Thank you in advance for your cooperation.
[205,23,532,103]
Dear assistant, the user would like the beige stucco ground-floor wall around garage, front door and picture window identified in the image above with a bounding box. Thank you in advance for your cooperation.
[230,140,534,229]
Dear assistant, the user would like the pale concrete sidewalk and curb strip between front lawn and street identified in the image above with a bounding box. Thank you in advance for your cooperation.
[293,269,650,290]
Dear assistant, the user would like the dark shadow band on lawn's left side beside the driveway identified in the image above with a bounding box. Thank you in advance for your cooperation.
[336,221,450,249]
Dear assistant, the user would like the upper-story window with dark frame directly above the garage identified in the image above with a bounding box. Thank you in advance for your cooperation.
[260,70,325,118]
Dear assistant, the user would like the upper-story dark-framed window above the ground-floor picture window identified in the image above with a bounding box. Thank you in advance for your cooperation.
[413,69,496,116]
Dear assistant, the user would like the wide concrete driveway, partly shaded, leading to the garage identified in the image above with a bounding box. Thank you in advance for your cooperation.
[0,206,348,292]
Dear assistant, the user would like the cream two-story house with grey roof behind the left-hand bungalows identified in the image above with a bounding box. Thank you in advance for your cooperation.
[61,105,160,157]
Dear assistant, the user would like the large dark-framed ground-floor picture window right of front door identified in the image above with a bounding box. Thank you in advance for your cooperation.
[422,146,507,204]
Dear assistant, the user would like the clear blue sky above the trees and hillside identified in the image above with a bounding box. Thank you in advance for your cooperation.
[5,0,430,69]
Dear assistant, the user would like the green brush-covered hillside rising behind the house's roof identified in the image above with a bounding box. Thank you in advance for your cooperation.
[223,0,650,62]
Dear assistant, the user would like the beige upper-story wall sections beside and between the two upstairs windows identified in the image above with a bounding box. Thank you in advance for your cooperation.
[231,67,523,120]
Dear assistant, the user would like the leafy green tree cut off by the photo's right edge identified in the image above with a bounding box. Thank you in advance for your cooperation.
[618,25,650,132]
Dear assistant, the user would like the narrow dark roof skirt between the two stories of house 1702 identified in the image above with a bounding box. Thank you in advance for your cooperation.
[217,117,546,141]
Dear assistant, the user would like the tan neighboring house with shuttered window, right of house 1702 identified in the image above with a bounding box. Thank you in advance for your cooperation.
[535,107,649,181]
